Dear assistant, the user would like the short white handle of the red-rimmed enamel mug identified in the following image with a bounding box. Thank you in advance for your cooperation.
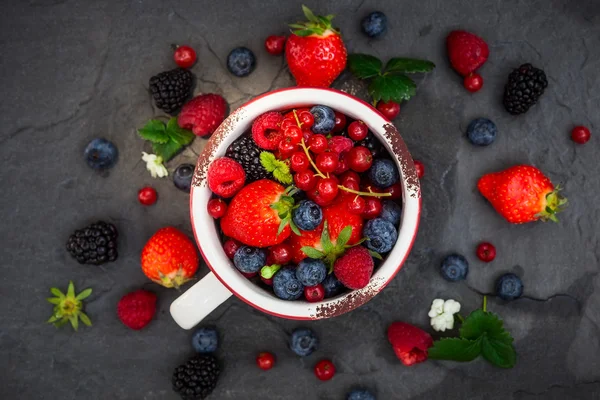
[170,272,231,329]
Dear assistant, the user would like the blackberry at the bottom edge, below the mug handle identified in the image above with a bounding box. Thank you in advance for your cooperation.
[173,354,221,400]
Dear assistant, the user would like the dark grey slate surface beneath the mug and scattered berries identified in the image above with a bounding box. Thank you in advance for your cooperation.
[0,0,600,400]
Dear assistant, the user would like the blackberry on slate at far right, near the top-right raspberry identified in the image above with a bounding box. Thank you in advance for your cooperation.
[504,64,548,115]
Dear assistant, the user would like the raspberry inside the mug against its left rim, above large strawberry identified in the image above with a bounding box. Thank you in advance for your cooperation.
[208,157,246,198]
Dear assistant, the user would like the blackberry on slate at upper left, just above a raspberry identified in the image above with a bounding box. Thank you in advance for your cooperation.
[150,68,194,114]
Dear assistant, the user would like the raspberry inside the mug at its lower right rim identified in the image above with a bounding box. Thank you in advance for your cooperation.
[333,246,374,289]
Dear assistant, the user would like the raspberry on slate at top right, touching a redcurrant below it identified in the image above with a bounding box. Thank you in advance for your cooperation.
[446,31,490,76]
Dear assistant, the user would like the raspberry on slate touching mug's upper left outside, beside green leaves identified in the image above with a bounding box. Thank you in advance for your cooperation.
[177,93,227,136]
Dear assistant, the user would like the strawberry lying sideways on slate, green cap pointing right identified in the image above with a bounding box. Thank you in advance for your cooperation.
[477,165,567,224]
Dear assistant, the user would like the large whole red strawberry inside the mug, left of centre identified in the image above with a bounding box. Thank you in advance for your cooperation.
[221,179,300,247]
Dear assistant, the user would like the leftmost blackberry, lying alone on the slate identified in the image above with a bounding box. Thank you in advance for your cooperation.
[67,221,119,265]
